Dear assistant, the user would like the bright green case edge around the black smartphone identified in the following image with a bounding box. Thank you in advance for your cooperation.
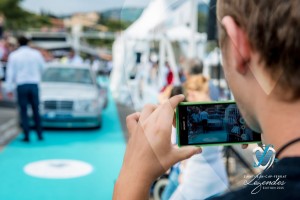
[176,101,260,147]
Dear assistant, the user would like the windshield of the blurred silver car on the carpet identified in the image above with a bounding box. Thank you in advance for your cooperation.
[43,67,93,84]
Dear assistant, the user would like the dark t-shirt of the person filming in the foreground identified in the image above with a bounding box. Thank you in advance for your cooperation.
[210,157,300,200]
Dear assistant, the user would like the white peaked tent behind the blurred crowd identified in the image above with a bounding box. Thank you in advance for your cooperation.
[111,0,205,109]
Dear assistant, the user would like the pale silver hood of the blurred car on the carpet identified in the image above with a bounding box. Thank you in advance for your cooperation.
[40,83,98,101]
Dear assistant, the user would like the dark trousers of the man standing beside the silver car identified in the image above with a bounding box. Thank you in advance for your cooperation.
[17,84,42,139]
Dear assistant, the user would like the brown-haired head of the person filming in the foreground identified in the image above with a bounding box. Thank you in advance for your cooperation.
[217,0,300,131]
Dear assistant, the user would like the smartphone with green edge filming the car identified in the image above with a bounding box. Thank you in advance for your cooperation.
[176,101,261,147]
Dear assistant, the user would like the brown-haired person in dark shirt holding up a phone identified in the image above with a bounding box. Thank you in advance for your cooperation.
[114,0,300,200]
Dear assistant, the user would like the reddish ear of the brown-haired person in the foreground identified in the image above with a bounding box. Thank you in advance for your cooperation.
[222,16,251,74]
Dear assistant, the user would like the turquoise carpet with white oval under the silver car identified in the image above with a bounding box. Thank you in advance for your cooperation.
[0,91,125,200]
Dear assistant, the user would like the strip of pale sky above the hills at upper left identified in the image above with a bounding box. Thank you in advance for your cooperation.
[21,0,150,15]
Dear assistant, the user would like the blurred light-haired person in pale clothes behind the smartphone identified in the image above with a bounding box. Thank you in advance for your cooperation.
[170,75,229,200]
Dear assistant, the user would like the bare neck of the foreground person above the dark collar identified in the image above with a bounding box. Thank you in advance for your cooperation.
[259,97,300,158]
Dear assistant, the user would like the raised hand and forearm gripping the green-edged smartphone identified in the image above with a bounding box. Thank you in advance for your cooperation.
[114,95,202,200]
